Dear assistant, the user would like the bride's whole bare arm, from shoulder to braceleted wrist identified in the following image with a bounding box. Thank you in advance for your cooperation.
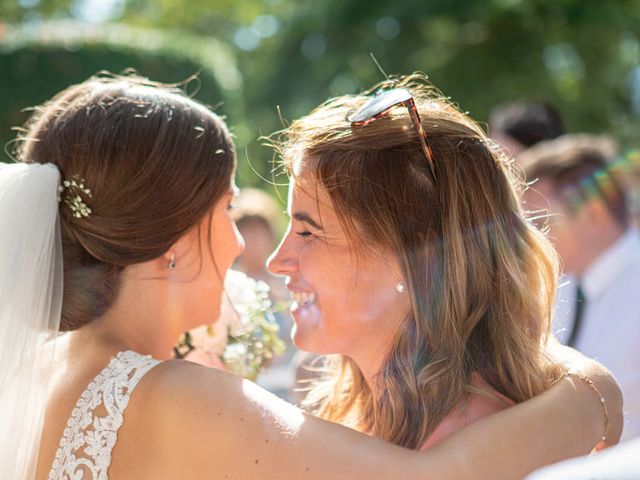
[130,352,619,480]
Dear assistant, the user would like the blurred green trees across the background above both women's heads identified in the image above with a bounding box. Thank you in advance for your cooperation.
[0,0,640,191]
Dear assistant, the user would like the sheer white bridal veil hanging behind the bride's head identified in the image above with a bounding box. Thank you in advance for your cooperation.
[0,163,62,480]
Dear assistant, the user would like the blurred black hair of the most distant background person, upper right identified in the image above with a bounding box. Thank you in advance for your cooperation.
[489,101,565,157]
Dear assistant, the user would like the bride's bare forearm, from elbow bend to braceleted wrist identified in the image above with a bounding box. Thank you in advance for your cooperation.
[433,377,621,480]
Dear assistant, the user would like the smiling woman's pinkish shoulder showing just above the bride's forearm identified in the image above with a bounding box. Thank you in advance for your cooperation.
[420,373,515,450]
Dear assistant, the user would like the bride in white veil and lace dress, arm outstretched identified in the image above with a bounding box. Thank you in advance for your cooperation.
[0,73,621,479]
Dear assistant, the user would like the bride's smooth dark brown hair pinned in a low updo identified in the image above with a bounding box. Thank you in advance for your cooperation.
[17,75,235,330]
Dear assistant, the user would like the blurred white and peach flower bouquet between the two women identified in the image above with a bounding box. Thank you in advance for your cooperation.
[174,270,286,380]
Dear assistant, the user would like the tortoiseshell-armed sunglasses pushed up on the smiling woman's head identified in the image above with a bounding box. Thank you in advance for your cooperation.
[347,88,436,180]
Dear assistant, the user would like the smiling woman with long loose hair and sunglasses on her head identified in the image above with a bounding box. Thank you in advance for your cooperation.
[270,75,608,456]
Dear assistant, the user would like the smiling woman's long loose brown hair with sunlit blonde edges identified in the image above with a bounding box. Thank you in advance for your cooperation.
[274,75,560,448]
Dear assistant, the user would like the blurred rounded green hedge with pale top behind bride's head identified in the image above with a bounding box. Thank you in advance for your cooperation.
[0,22,242,169]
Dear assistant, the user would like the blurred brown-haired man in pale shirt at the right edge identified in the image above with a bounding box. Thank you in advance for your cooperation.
[518,135,640,440]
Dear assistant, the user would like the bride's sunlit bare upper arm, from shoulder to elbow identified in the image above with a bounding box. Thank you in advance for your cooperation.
[134,361,444,480]
